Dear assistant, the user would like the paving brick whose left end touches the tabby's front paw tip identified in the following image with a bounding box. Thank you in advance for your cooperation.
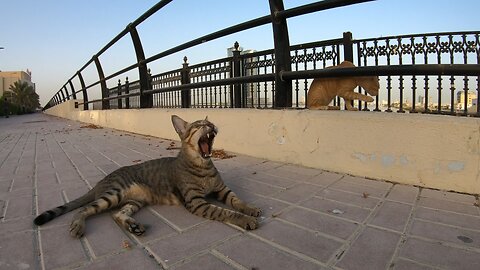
[253,220,342,263]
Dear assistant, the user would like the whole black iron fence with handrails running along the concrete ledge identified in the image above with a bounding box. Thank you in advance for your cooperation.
[45,0,480,116]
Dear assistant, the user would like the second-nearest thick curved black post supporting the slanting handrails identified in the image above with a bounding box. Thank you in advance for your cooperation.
[127,24,153,108]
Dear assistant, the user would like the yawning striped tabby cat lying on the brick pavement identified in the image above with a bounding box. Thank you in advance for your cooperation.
[33,115,261,238]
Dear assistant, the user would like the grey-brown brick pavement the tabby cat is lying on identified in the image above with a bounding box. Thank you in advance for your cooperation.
[0,114,480,270]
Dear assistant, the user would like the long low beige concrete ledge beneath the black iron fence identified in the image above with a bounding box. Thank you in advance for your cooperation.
[45,100,480,194]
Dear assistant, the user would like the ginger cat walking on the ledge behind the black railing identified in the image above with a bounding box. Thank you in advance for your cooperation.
[307,61,380,111]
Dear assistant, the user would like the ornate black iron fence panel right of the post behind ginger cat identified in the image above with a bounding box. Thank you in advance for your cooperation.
[354,32,480,115]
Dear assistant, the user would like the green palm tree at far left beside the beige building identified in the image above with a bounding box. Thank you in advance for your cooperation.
[9,80,40,112]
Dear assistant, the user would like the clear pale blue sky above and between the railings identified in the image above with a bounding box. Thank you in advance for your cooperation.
[0,0,480,105]
